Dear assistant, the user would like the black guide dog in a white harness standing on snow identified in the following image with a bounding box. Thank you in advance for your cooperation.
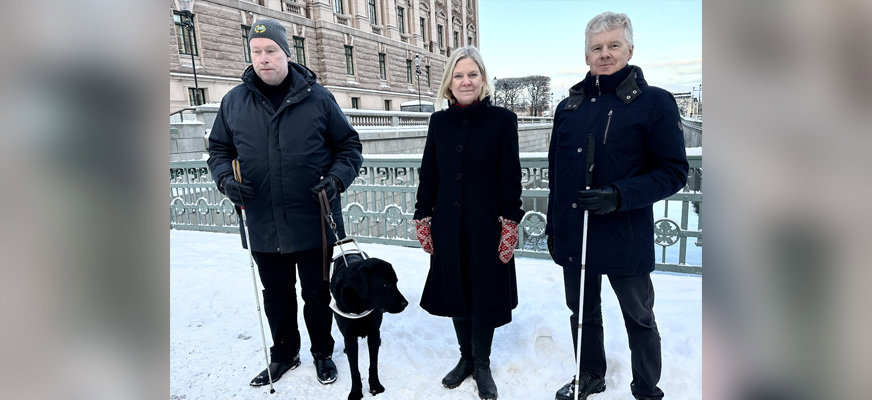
[330,252,409,400]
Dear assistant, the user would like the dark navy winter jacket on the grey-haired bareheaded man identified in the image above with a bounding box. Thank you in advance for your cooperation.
[545,66,688,275]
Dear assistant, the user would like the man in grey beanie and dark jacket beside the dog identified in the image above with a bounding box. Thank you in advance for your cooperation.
[209,20,363,386]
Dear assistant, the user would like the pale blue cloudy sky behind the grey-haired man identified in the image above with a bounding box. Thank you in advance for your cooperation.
[479,0,702,100]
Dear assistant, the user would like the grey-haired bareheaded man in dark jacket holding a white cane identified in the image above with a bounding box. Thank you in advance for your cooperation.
[545,12,688,400]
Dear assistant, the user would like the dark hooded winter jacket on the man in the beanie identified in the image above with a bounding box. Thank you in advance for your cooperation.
[209,63,363,253]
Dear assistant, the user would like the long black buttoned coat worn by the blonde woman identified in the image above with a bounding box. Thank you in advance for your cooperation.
[415,98,524,327]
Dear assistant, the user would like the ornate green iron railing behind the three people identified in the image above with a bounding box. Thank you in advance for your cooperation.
[170,153,702,274]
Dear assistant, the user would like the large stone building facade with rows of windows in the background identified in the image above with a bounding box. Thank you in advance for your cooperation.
[168,0,479,112]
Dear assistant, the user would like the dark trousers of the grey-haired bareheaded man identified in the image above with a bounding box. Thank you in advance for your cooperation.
[563,268,663,398]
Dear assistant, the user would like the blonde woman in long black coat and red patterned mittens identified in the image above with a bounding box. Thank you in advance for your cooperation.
[414,47,524,399]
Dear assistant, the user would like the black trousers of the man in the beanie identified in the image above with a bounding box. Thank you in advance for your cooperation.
[252,248,334,362]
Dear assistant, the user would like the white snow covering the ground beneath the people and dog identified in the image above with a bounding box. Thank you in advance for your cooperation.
[170,230,702,400]
